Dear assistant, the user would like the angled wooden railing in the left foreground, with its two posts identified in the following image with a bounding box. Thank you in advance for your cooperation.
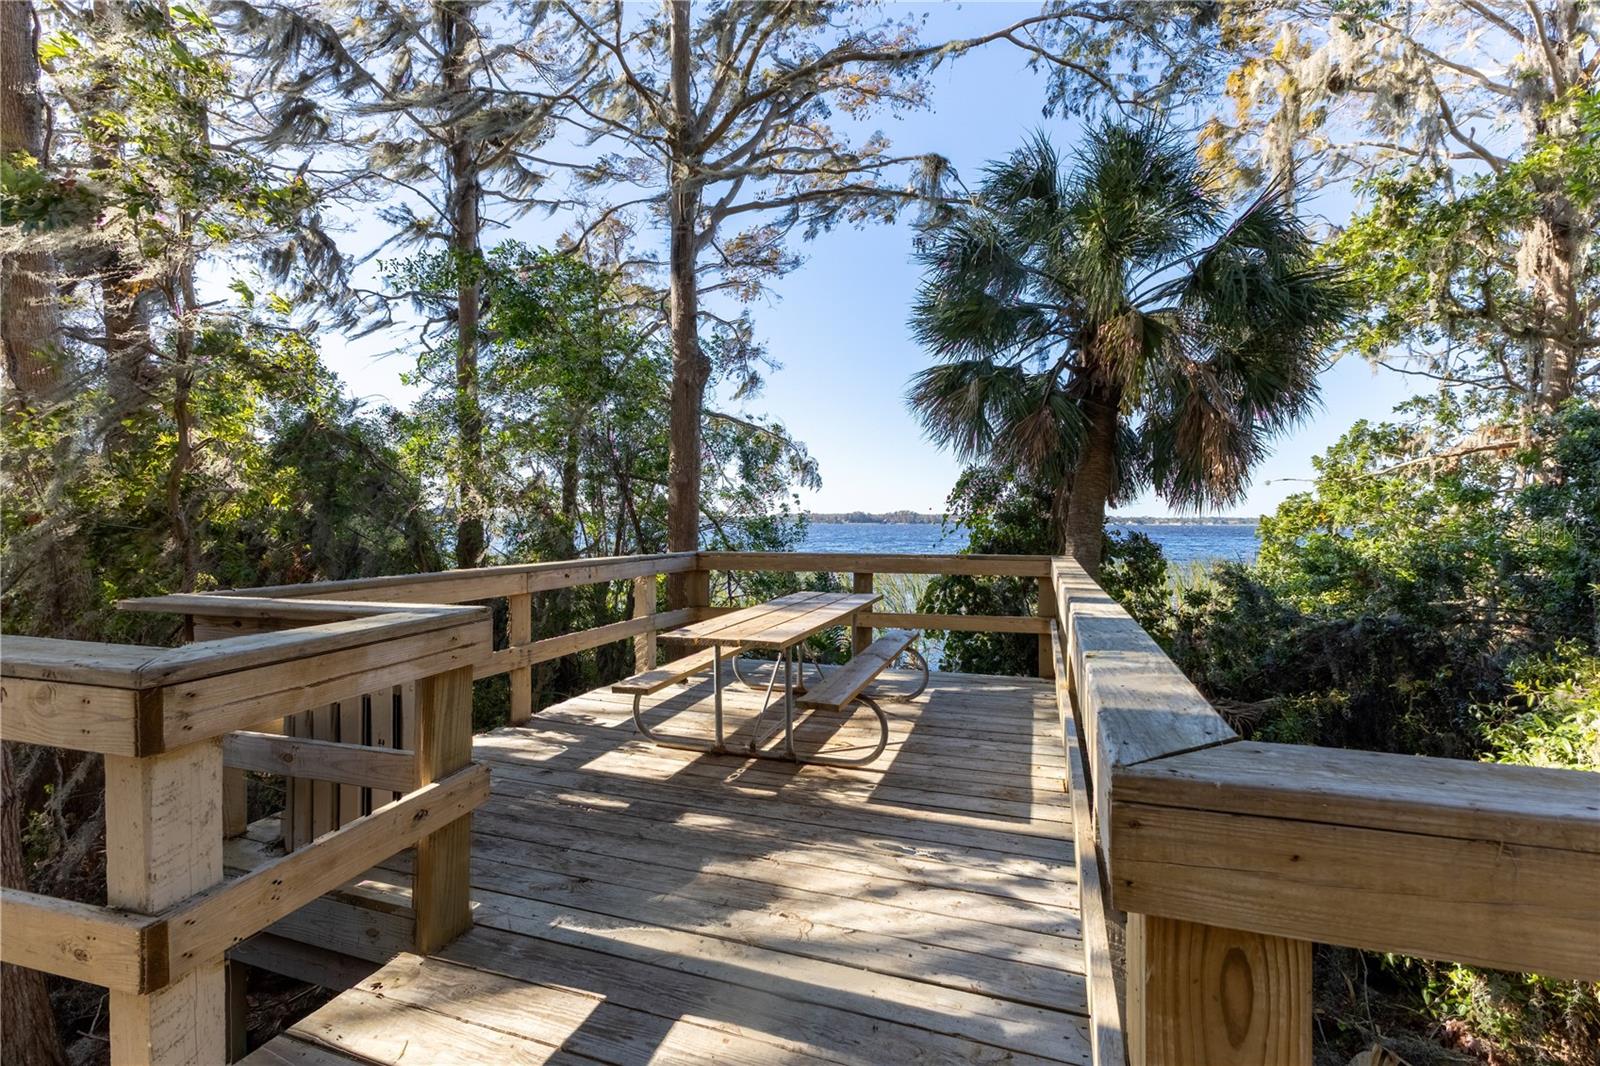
[0,599,491,1063]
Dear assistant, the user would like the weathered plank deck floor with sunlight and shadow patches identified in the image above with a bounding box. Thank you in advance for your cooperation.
[248,674,1088,1066]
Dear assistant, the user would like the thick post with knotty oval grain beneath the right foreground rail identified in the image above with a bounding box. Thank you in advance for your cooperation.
[1126,914,1312,1066]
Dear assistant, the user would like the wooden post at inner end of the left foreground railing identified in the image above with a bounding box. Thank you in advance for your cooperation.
[411,666,472,956]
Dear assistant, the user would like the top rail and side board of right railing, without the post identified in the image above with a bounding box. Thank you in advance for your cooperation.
[1054,559,1600,980]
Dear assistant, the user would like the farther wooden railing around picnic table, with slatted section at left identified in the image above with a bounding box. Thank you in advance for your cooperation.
[122,552,1054,870]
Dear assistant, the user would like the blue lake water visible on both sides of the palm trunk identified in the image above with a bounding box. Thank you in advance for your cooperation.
[800,522,1256,565]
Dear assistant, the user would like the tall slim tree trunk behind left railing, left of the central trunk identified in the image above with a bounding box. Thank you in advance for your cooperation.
[438,0,486,568]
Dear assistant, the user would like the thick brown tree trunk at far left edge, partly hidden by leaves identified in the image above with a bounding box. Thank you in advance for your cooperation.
[0,0,58,403]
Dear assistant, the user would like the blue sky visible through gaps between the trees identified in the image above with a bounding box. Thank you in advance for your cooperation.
[312,3,1416,515]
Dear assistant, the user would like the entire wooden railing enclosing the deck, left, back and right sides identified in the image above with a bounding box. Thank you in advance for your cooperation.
[12,552,1600,1066]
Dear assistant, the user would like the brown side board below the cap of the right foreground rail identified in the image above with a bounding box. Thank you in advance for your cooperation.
[1112,791,1600,980]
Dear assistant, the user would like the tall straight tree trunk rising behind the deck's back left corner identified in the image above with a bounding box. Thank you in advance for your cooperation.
[667,0,710,608]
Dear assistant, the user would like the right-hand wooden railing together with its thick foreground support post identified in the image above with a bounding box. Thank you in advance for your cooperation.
[1053,559,1600,1066]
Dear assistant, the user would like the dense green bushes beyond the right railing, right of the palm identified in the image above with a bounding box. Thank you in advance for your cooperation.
[1171,398,1600,757]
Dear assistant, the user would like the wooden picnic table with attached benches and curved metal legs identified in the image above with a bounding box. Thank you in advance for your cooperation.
[613,592,926,765]
